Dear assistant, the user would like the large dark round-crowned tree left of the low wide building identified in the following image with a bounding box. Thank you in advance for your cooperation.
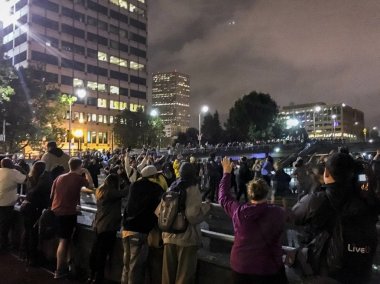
[226,91,278,141]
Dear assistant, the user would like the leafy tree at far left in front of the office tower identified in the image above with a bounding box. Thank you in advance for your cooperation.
[0,63,64,152]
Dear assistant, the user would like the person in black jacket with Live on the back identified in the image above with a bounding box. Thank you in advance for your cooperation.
[292,153,379,284]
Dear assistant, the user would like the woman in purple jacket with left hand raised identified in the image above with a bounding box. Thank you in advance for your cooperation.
[219,157,288,284]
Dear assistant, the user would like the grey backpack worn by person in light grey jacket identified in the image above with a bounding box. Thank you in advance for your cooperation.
[158,181,189,234]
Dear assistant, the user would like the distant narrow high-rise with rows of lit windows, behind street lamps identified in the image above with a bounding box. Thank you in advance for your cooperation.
[152,71,190,136]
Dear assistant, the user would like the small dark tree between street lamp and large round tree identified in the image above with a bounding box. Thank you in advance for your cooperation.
[201,111,223,145]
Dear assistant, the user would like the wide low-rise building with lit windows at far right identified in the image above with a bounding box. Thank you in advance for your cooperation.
[280,102,364,140]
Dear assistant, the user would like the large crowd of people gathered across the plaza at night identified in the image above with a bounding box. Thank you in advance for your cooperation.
[0,142,380,284]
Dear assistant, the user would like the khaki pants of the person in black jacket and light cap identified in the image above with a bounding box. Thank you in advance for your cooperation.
[121,233,149,284]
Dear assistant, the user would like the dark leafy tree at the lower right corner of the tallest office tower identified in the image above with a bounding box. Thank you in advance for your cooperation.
[114,108,152,147]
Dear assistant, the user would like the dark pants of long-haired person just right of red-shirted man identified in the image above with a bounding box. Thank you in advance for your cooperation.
[90,231,116,281]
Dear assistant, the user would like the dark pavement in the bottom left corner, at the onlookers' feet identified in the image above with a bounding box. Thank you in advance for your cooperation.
[0,253,79,284]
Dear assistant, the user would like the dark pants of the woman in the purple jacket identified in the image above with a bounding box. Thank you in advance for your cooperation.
[232,267,288,284]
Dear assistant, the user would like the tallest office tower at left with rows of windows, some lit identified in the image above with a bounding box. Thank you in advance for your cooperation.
[3,0,147,149]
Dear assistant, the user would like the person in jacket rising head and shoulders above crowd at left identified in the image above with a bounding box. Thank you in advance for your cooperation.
[41,141,70,173]
